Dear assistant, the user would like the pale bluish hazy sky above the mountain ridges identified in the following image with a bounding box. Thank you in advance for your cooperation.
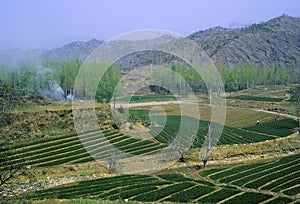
[0,0,300,49]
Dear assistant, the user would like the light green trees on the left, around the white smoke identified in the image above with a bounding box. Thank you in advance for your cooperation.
[0,60,121,102]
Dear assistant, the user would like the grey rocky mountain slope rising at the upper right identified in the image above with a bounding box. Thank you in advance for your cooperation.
[188,16,300,66]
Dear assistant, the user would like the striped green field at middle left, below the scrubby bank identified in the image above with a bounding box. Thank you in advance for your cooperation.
[1,128,166,169]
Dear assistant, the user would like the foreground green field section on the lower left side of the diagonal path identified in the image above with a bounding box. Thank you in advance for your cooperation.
[27,172,299,203]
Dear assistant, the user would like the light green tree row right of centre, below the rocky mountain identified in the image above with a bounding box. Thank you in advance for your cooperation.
[153,62,300,93]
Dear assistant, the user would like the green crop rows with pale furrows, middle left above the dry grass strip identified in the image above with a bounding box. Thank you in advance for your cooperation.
[4,126,169,166]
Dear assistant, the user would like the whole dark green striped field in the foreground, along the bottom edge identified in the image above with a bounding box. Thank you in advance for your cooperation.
[24,154,300,203]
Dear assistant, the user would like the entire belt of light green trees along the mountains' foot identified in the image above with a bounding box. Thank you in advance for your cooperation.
[0,60,300,102]
